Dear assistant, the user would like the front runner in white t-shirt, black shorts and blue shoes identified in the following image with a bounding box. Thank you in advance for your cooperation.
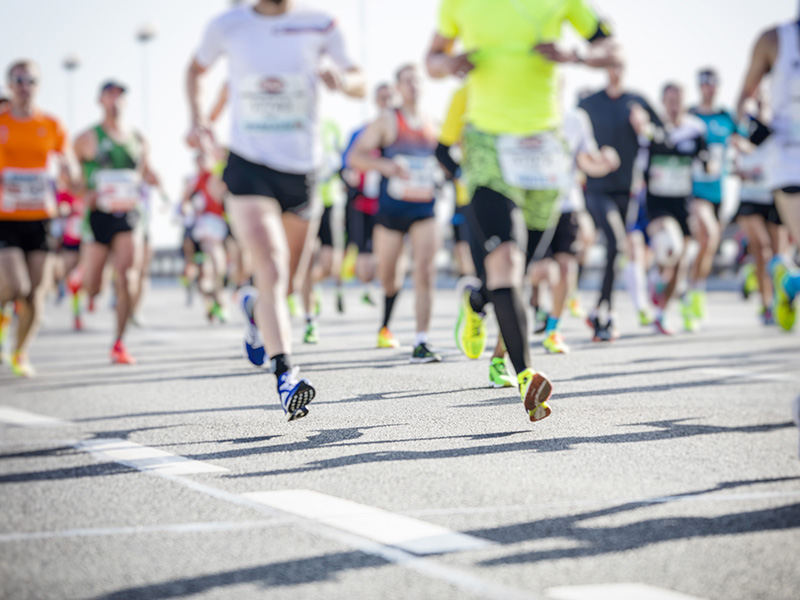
[187,0,364,420]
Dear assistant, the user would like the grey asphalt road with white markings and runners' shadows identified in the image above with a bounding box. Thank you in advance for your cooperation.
[0,288,800,600]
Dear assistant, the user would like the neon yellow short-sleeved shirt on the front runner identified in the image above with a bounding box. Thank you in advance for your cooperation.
[439,0,600,135]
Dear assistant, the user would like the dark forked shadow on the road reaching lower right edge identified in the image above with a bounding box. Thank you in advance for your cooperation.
[466,477,800,566]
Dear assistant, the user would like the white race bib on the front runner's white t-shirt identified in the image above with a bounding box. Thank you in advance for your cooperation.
[239,75,310,135]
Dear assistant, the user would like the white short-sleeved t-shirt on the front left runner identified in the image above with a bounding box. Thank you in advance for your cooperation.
[196,6,354,174]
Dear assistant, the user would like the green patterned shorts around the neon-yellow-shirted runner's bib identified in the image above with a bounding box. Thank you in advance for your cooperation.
[461,127,567,231]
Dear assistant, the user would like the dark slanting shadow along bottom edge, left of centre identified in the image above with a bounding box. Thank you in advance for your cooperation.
[90,551,388,600]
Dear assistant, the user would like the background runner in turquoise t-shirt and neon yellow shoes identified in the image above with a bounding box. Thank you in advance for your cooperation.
[681,69,737,331]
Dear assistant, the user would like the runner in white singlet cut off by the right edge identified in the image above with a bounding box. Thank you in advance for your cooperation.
[738,12,800,331]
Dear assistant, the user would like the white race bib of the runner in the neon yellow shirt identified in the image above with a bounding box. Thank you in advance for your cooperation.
[497,134,569,190]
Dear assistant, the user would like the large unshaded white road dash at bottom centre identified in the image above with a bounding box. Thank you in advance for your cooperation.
[245,490,494,555]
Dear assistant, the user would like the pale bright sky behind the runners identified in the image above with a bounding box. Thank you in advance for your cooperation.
[0,0,797,246]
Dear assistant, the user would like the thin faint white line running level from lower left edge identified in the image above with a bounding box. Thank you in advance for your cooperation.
[0,519,292,543]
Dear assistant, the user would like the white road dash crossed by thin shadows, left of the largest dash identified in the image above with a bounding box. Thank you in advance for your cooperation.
[75,438,228,475]
